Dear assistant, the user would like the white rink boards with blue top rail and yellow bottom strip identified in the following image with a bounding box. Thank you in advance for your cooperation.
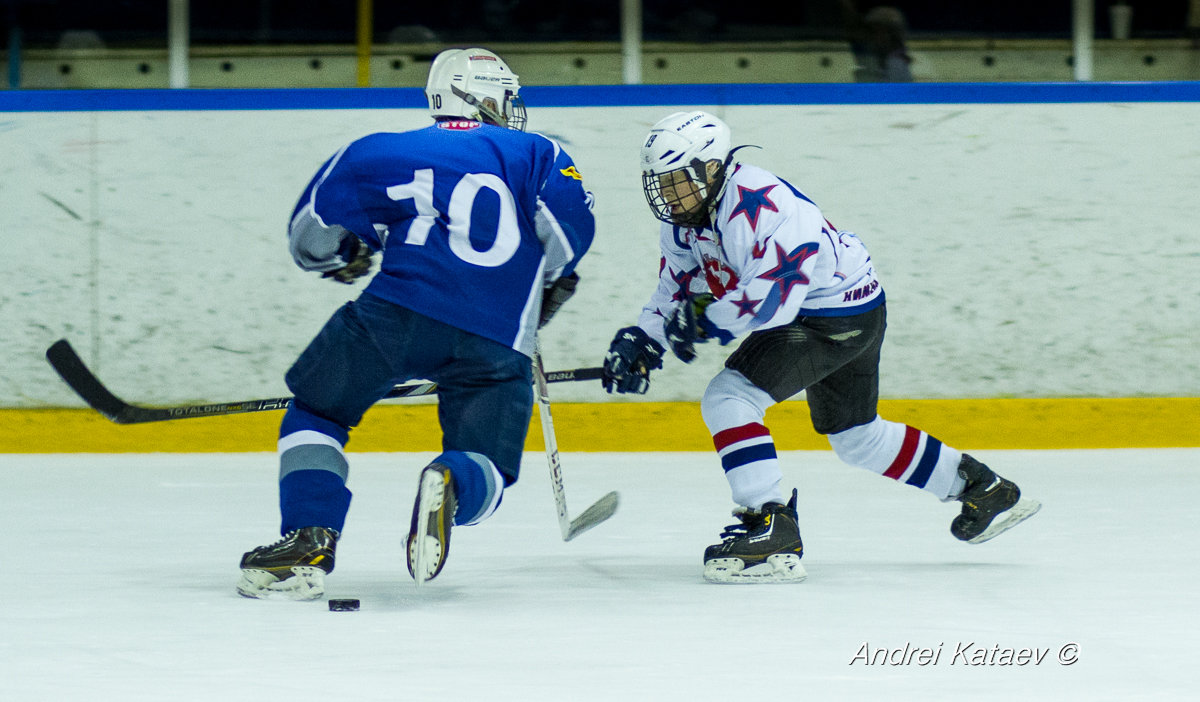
[0,83,1200,451]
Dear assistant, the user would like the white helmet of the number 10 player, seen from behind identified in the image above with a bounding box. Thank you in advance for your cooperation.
[425,48,526,132]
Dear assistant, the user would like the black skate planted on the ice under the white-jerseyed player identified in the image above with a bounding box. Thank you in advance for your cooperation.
[704,490,808,583]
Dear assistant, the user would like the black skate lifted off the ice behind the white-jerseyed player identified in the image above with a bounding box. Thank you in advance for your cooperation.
[950,454,1042,544]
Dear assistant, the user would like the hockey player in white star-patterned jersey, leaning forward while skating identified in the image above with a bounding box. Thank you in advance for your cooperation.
[604,112,1040,583]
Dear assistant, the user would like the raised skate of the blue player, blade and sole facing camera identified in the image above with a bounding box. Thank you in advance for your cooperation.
[408,463,458,587]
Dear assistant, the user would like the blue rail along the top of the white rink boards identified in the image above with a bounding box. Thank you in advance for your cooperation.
[0,82,1200,112]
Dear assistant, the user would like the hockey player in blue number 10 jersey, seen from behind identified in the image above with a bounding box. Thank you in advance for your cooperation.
[238,49,594,600]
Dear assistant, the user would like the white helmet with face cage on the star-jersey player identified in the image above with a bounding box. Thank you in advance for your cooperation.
[641,110,732,227]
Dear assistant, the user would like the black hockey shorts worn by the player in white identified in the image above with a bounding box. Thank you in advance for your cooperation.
[725,305,887,434]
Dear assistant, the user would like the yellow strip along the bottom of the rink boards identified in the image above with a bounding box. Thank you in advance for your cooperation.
[0,397,1200,454]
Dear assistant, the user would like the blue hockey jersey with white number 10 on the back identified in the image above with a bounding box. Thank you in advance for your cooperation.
[288,120,595,355]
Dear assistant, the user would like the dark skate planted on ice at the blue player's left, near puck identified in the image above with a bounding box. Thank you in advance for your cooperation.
[238,527,338,600]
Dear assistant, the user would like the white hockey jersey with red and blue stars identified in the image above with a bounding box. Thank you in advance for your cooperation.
[638,164,883,344]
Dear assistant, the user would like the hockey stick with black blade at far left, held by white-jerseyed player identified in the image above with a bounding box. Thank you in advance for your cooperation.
[46,338,601,424]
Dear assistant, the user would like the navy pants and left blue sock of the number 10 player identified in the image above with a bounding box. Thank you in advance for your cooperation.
[280,293,533,533]
